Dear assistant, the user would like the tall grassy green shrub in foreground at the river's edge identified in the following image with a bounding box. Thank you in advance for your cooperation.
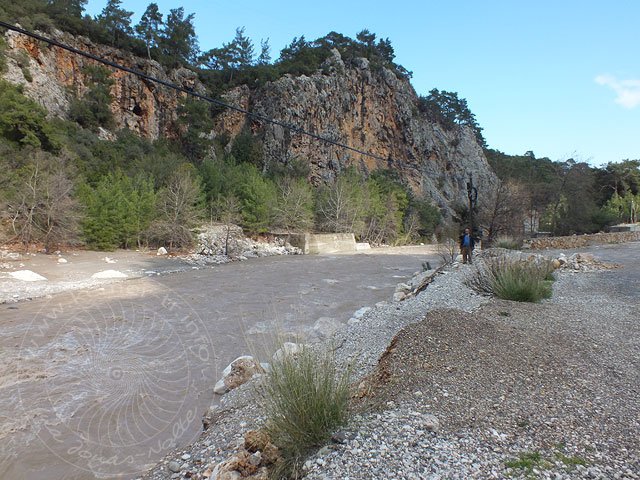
[262,347,350,478]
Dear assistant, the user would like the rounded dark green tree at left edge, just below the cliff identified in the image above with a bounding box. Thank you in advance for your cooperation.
[0,80,60,152]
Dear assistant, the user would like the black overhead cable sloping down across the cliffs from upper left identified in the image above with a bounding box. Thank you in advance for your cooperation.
[0,20,389,162]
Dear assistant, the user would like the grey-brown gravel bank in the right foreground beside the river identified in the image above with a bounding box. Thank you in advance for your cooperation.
[148,244,640,480]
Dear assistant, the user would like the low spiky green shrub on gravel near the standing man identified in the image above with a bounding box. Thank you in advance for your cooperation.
[468,256,553,302]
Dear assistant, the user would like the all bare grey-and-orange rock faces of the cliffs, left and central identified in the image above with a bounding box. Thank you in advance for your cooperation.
[5,28,497,218]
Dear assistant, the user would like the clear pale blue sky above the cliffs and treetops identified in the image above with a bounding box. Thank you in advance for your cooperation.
[85,0,640,166]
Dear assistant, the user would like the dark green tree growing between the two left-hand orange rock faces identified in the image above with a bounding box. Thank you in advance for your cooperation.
[69,66,114,132]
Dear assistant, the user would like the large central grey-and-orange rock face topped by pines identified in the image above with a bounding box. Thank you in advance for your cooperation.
[216,50,497,217]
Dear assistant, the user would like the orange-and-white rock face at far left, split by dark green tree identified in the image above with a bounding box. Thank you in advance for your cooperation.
[4,27,201,139]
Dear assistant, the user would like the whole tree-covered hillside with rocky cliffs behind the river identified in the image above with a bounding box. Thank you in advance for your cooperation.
[0,0,640,250]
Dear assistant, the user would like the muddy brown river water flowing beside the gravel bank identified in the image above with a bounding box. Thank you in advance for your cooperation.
[0,248,439,480]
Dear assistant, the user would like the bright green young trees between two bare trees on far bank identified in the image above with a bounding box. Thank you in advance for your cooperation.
[80,171,156,250]
